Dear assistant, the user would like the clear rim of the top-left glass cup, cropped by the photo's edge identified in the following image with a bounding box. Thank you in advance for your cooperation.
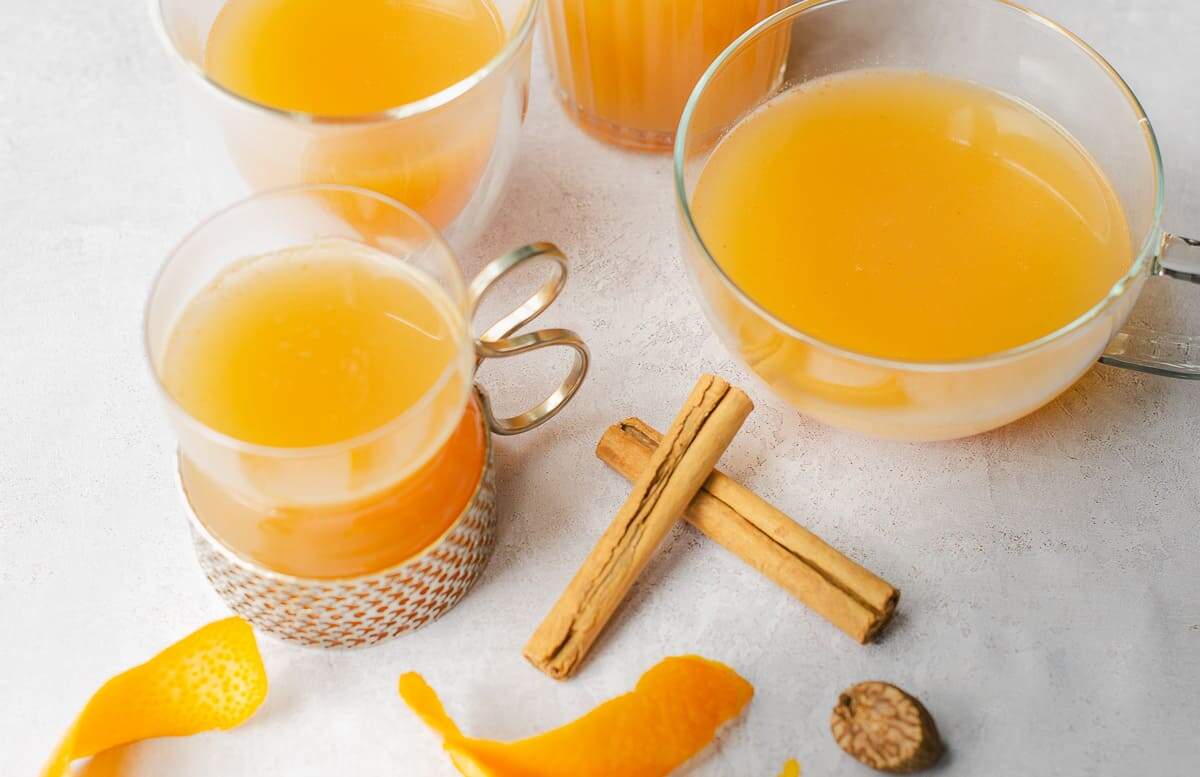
[149,0,542,126]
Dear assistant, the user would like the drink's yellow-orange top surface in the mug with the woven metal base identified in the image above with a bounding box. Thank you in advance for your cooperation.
[162,240,462,447]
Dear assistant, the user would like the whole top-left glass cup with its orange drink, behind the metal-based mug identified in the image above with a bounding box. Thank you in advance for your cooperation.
[160,0,533,246]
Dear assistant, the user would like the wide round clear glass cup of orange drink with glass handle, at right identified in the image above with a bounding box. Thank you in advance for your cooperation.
[676,0,1200,440]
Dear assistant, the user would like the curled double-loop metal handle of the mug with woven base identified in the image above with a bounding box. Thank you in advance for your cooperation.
[467,242,589,435]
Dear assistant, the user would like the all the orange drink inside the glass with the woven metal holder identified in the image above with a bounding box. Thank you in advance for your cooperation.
[160,240,487,578]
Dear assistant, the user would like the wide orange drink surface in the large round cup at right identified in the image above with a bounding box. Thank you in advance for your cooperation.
[692,71,1132,362]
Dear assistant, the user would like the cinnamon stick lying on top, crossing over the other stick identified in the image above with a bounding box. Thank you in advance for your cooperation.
[524,375,754,680]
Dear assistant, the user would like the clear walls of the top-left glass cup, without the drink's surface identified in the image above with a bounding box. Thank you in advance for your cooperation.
[154,0,539,249]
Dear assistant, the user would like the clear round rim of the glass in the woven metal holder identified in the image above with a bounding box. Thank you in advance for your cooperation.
[142,183,474,459]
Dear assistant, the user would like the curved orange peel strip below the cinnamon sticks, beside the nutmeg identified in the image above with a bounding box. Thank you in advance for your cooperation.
[400,656,754,777]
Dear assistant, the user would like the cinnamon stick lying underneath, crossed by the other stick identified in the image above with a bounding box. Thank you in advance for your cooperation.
[596,418,900,643]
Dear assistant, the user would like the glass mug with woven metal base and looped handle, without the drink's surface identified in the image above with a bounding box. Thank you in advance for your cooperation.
[145,185,588,646]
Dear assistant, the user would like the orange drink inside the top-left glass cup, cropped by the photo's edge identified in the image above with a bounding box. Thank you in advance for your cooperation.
[204,0,506,230]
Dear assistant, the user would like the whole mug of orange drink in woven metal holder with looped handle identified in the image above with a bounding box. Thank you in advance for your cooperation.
[146,186,586,646]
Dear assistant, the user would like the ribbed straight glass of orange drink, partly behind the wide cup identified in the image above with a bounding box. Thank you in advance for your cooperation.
[542,0,793,150]
